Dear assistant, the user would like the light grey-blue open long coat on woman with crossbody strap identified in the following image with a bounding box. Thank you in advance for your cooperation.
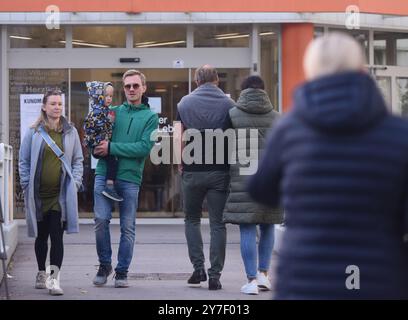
[18,118,83,237]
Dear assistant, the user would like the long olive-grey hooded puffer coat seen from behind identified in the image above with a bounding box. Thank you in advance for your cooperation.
[223,88,282,224]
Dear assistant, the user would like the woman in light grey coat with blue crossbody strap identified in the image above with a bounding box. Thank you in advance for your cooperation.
[19,90,83,295]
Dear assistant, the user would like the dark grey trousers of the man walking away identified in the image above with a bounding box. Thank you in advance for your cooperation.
[182,171,230,279]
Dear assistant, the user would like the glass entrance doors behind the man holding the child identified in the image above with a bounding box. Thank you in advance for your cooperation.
[70,68,249,218]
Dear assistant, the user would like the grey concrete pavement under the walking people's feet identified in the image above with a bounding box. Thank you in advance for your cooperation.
[0,219,276,300]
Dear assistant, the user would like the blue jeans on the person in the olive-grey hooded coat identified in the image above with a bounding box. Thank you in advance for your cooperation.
[239,223,275,280]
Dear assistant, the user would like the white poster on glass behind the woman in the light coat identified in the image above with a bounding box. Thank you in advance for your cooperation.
[20,93,65,139]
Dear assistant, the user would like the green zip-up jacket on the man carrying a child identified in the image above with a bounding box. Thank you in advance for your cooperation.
[96,102,159,185]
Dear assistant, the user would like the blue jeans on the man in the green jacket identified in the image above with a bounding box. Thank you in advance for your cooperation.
[94,175,139,274]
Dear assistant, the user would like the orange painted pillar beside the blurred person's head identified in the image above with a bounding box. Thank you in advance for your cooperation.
[282,23,314,112]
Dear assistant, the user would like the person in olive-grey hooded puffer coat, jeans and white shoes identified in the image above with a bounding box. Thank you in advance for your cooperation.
[224,76,282,294]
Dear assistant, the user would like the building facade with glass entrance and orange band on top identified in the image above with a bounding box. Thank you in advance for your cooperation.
[0,0,408,218]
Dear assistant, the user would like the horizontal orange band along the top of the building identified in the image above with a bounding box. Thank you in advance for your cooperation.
[0,0,408,15]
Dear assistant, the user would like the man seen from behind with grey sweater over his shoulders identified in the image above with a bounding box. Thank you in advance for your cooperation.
[177,65,234,290]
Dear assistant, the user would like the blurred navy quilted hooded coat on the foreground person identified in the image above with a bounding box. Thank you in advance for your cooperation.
[249,72,408,299]
